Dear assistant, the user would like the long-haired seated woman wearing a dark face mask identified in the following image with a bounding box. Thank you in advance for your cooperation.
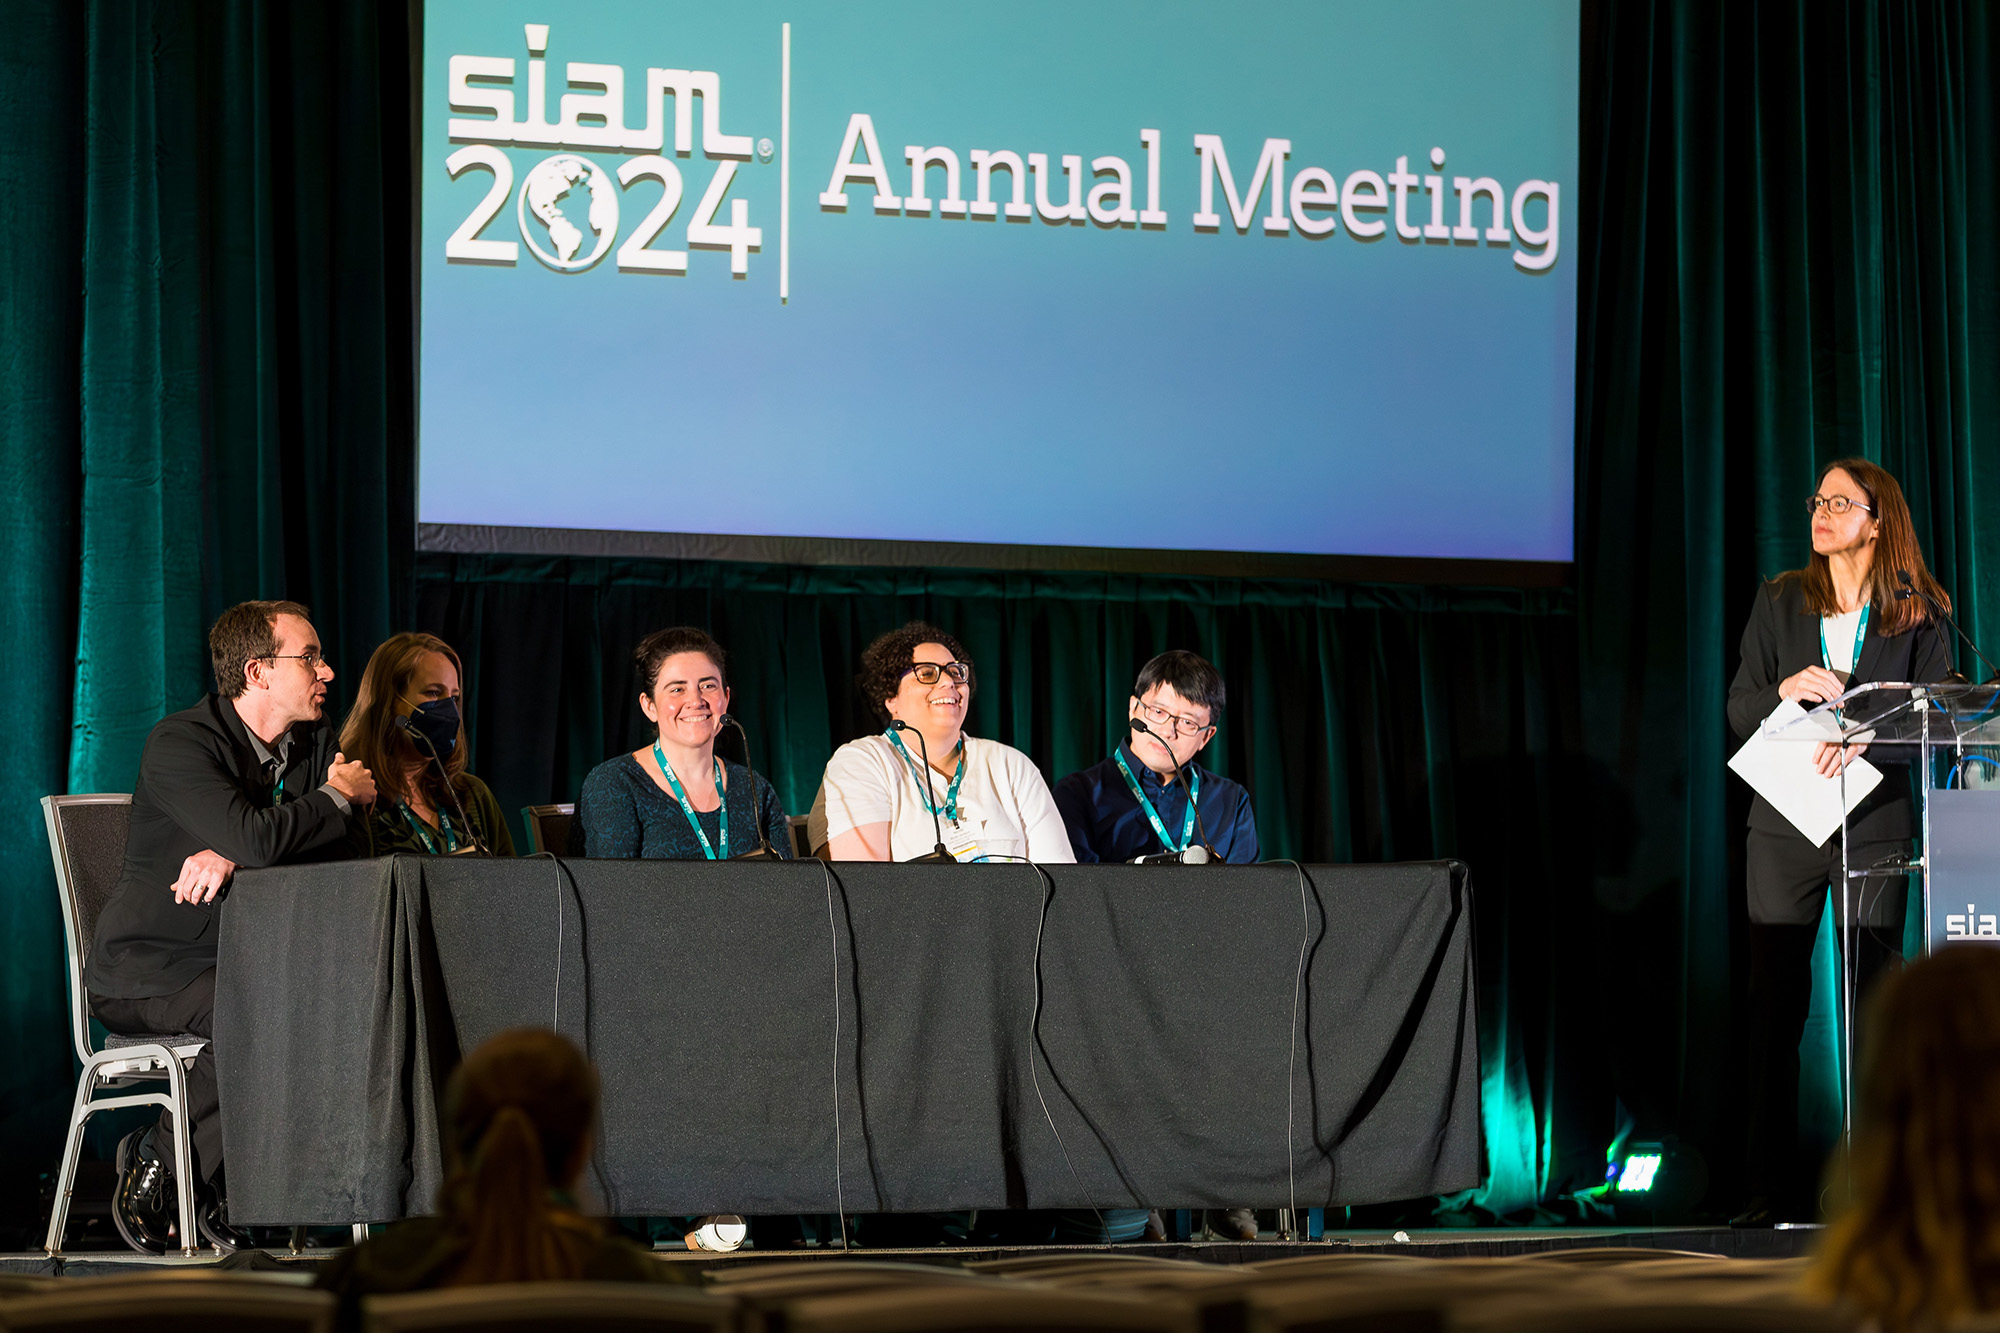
[340,632,514,857]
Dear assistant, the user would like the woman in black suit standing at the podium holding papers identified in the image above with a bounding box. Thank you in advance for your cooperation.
[1728,458,1952,1225]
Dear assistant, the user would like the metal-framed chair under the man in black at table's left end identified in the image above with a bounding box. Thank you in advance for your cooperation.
[40,795,208,1248]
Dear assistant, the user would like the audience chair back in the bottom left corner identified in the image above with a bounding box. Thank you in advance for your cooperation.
[0,1275,338,1333]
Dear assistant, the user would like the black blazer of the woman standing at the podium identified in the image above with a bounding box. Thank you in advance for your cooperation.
[1730,578,1952,843]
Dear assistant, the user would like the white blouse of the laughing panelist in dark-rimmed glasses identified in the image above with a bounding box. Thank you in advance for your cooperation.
[806,737,1076,863]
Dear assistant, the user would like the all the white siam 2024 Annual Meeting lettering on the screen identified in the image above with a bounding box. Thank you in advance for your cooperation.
[444,24,1562,290]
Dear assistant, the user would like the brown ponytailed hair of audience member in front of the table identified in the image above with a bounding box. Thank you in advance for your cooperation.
[438,1027,600,1287]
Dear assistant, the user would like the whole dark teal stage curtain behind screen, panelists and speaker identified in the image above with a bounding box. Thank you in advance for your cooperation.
[0,0,2000,1231]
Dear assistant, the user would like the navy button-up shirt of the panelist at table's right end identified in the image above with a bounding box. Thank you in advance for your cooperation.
[1056,741,1258,865]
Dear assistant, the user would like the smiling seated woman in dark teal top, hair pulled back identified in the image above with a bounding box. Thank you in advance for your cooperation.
[572,628,792,861]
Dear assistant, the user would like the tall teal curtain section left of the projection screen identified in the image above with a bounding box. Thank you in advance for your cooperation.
[0,0,414,1221]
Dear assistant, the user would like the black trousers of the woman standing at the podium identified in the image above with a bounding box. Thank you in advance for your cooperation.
[1744,829,1908,1207]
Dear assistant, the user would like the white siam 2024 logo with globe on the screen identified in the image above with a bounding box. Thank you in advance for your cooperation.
[444,24,772,276]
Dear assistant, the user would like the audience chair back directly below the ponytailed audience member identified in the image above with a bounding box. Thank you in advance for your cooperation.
[362,1283,736,1333]
